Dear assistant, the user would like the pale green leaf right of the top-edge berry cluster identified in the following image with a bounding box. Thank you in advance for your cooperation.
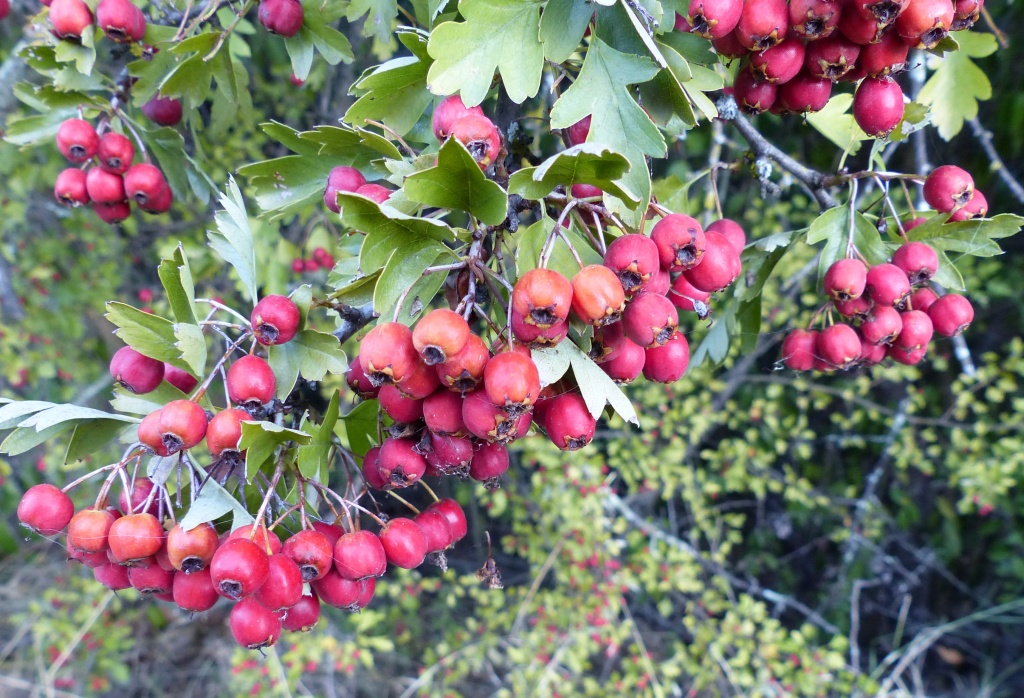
[918,32,998,140]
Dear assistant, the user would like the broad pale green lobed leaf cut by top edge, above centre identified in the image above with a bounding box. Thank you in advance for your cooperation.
[427,0,544,106]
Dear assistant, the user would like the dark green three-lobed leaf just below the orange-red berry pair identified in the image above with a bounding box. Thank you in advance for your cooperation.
[402,138,508,225]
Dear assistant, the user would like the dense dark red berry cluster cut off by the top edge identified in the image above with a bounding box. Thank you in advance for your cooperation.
[676,0,984,137]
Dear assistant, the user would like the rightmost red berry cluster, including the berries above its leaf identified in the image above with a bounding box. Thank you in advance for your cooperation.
[782,165,988,372]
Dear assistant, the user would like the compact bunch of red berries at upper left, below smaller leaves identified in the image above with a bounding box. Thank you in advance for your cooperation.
[53,119,174,223]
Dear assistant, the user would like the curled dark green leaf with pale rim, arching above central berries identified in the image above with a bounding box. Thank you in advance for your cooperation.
[509,143,640,208]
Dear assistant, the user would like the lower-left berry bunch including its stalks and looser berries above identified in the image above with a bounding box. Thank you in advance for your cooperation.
[17,296,475,649]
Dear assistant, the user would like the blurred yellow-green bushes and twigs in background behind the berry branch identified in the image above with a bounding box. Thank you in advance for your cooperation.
[0,3,1024,697]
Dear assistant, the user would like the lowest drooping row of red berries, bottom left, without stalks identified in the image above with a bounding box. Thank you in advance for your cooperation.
[17,478,466,649]
